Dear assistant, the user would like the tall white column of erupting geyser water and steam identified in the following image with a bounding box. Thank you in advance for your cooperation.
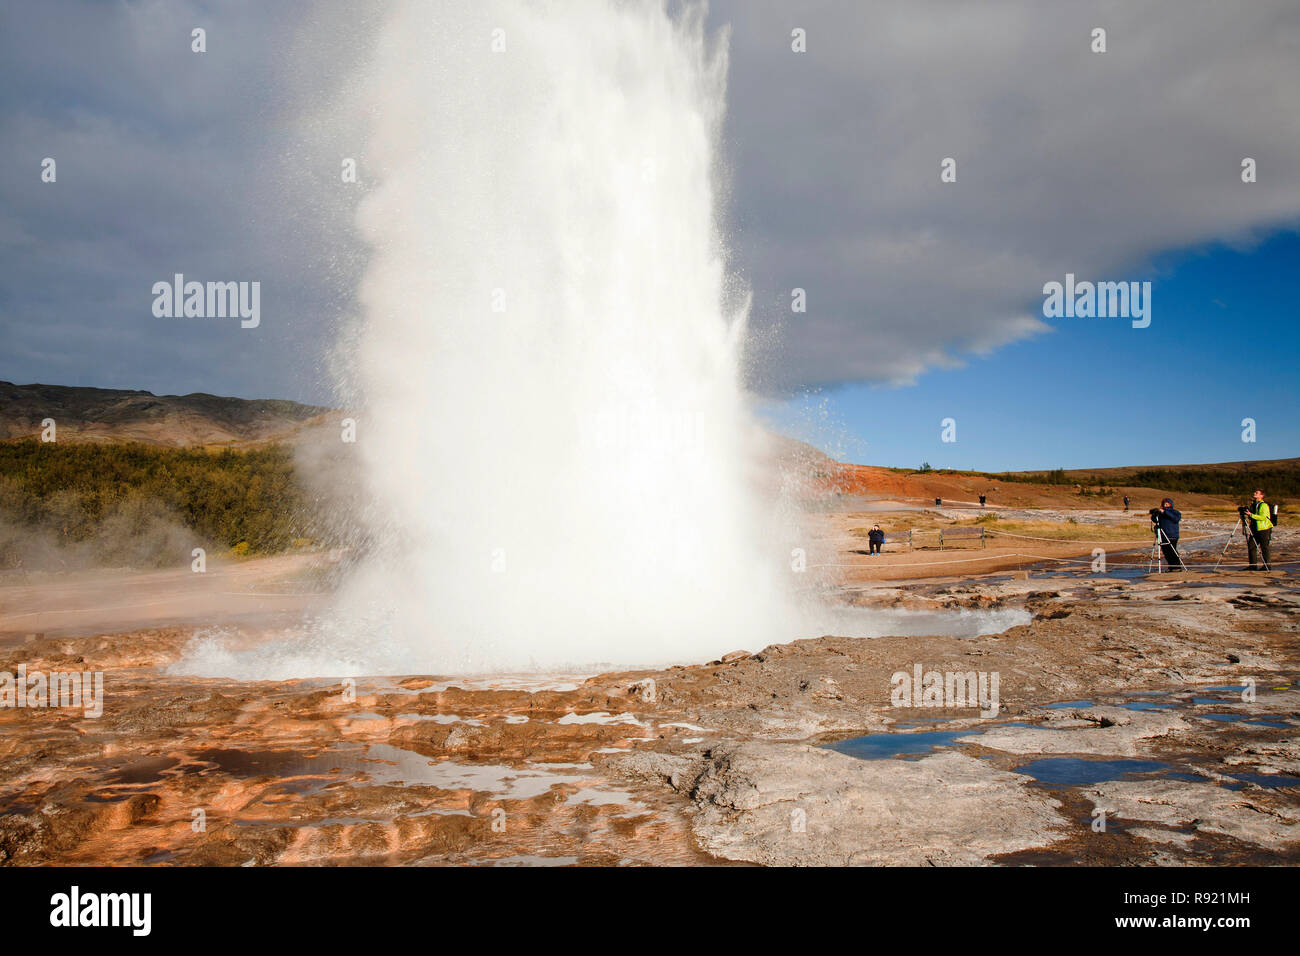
[329,0,790,672]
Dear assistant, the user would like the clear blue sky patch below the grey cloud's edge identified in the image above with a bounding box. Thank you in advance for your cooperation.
[764,232,1300,471]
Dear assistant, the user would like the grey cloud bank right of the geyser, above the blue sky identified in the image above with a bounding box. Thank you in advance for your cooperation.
[712,0,1300,392]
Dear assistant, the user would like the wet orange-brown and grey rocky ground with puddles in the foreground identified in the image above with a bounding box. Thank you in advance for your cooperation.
[0,575,1300,865]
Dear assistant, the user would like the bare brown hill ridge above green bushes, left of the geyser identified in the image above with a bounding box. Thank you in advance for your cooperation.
[0,381,338,447]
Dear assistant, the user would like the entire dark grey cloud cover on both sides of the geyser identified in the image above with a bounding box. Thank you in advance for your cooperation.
[0,0,1300,401]
